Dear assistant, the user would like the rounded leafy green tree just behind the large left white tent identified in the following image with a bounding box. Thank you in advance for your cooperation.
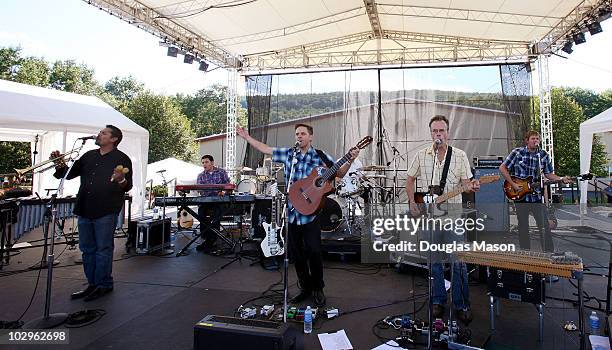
[125,91,197,163]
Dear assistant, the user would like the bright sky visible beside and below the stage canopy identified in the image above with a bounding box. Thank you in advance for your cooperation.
[0,0,612,94]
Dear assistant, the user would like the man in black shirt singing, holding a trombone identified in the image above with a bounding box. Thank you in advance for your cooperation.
[51,125,132,301]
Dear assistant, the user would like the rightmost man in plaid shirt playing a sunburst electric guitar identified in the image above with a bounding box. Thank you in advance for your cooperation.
[499,130,572,252]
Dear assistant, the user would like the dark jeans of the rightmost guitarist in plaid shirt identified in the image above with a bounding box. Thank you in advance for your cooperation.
[516,202,555,252]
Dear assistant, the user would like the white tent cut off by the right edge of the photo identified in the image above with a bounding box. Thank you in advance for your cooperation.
[580,108,612,203]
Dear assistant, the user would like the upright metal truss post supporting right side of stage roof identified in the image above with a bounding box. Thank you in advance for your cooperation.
[538,55,555,167]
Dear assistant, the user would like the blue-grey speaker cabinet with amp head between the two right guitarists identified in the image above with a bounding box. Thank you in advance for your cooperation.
[474,167,510,232]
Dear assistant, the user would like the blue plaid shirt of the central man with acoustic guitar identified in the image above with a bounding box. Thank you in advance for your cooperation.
[272,146,335,225]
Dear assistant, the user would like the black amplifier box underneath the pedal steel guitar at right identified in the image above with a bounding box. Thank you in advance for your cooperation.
[487,266,546,304]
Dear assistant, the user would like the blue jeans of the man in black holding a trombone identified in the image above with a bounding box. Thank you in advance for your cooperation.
[78,214,117,288]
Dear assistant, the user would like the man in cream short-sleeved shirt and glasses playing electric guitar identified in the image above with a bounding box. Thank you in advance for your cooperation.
[406,115,480,324]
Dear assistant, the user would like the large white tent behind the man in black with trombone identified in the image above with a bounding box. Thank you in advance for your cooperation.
[0,80,149,213]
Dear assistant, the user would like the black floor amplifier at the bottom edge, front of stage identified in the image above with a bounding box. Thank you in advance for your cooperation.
[193,315,304,350]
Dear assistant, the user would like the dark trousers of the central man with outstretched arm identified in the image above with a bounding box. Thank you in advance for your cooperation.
[288,217,325,291]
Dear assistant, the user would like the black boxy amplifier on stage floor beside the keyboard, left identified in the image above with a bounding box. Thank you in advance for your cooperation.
[136,217,172,254]
